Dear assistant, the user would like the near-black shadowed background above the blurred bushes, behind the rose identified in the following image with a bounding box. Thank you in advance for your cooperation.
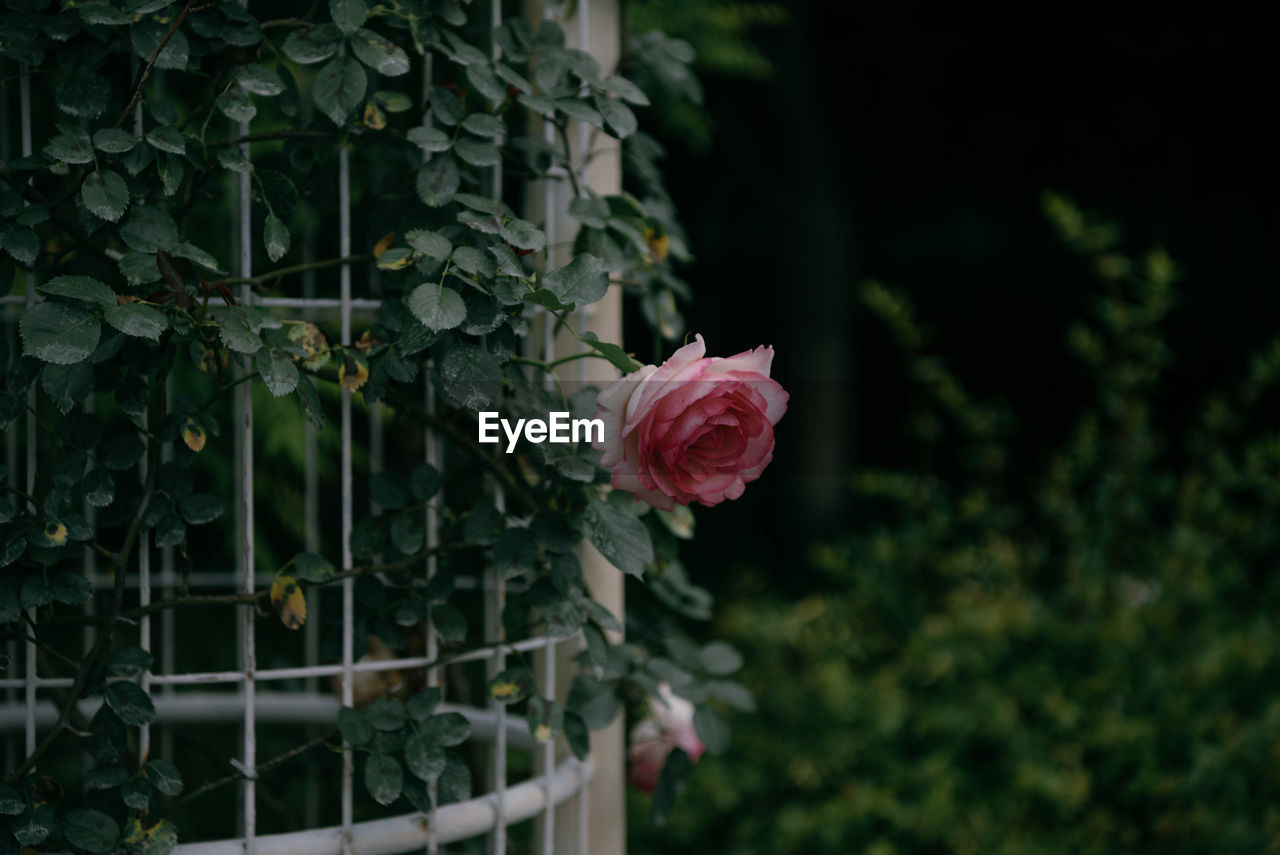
[628,16,1280,590]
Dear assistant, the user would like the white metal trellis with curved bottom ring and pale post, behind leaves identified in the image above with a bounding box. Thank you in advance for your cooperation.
[0,0,625,855]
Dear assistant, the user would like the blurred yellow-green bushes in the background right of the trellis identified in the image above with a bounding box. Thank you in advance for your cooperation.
[632,196,1280,855]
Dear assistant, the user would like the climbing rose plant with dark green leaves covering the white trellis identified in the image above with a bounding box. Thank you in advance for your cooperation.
[0,0,762,854]
